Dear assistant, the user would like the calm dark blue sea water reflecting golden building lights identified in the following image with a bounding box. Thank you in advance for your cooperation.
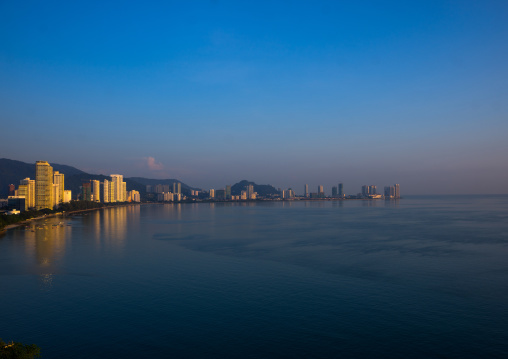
[0,196,508,358]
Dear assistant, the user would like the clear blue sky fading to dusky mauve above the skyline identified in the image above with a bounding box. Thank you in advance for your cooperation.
[0,0,508,195]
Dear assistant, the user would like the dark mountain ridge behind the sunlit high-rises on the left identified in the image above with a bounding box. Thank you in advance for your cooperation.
[0,158,194,198]
